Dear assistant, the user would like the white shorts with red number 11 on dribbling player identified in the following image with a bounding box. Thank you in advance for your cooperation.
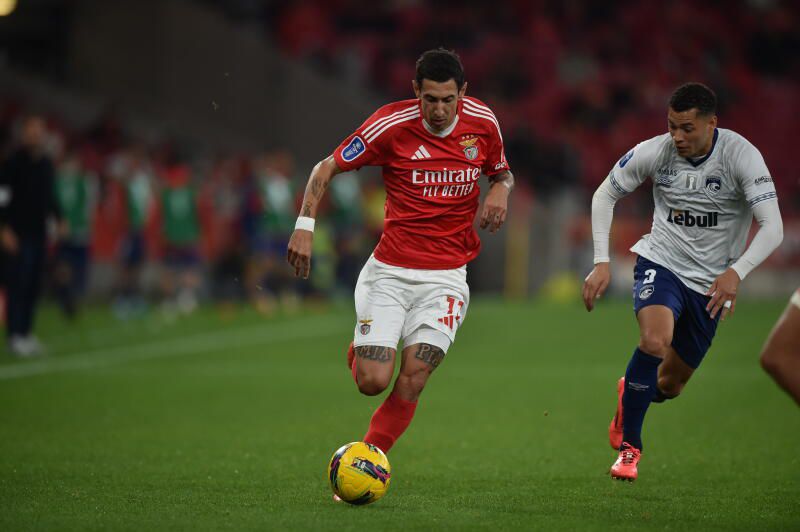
[353,256,469,353]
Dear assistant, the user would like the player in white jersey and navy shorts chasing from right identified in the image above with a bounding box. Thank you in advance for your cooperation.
[583,83,783,481]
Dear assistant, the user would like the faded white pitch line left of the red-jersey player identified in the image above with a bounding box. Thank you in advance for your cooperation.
[0,318,347,380]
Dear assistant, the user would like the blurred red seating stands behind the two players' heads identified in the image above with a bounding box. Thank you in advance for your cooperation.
[260,0,800,210]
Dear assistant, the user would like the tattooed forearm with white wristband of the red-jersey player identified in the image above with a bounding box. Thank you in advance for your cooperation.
[286,156,341,279]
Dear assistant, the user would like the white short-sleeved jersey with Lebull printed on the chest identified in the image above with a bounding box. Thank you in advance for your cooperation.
[609,128,777,293]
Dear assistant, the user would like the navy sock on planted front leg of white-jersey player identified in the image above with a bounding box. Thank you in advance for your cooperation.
[622,348,661,450]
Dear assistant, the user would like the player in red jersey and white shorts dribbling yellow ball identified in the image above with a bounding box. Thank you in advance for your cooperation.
[287,48,514,452]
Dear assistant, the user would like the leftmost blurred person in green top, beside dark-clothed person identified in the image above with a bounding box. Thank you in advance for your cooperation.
[53,152,98,318]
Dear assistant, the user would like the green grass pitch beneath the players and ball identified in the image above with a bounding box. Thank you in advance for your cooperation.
[0,299,800,531]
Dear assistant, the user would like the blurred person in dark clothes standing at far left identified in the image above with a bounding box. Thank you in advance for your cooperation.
[0,115,66,357]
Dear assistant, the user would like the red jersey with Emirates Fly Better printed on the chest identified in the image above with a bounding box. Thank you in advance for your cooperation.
[333,97,508,270]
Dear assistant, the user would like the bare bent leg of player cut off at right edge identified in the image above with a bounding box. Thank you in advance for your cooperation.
[761,288,800,405]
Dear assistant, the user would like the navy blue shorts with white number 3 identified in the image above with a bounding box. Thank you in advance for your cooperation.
[633,257,722,369]
